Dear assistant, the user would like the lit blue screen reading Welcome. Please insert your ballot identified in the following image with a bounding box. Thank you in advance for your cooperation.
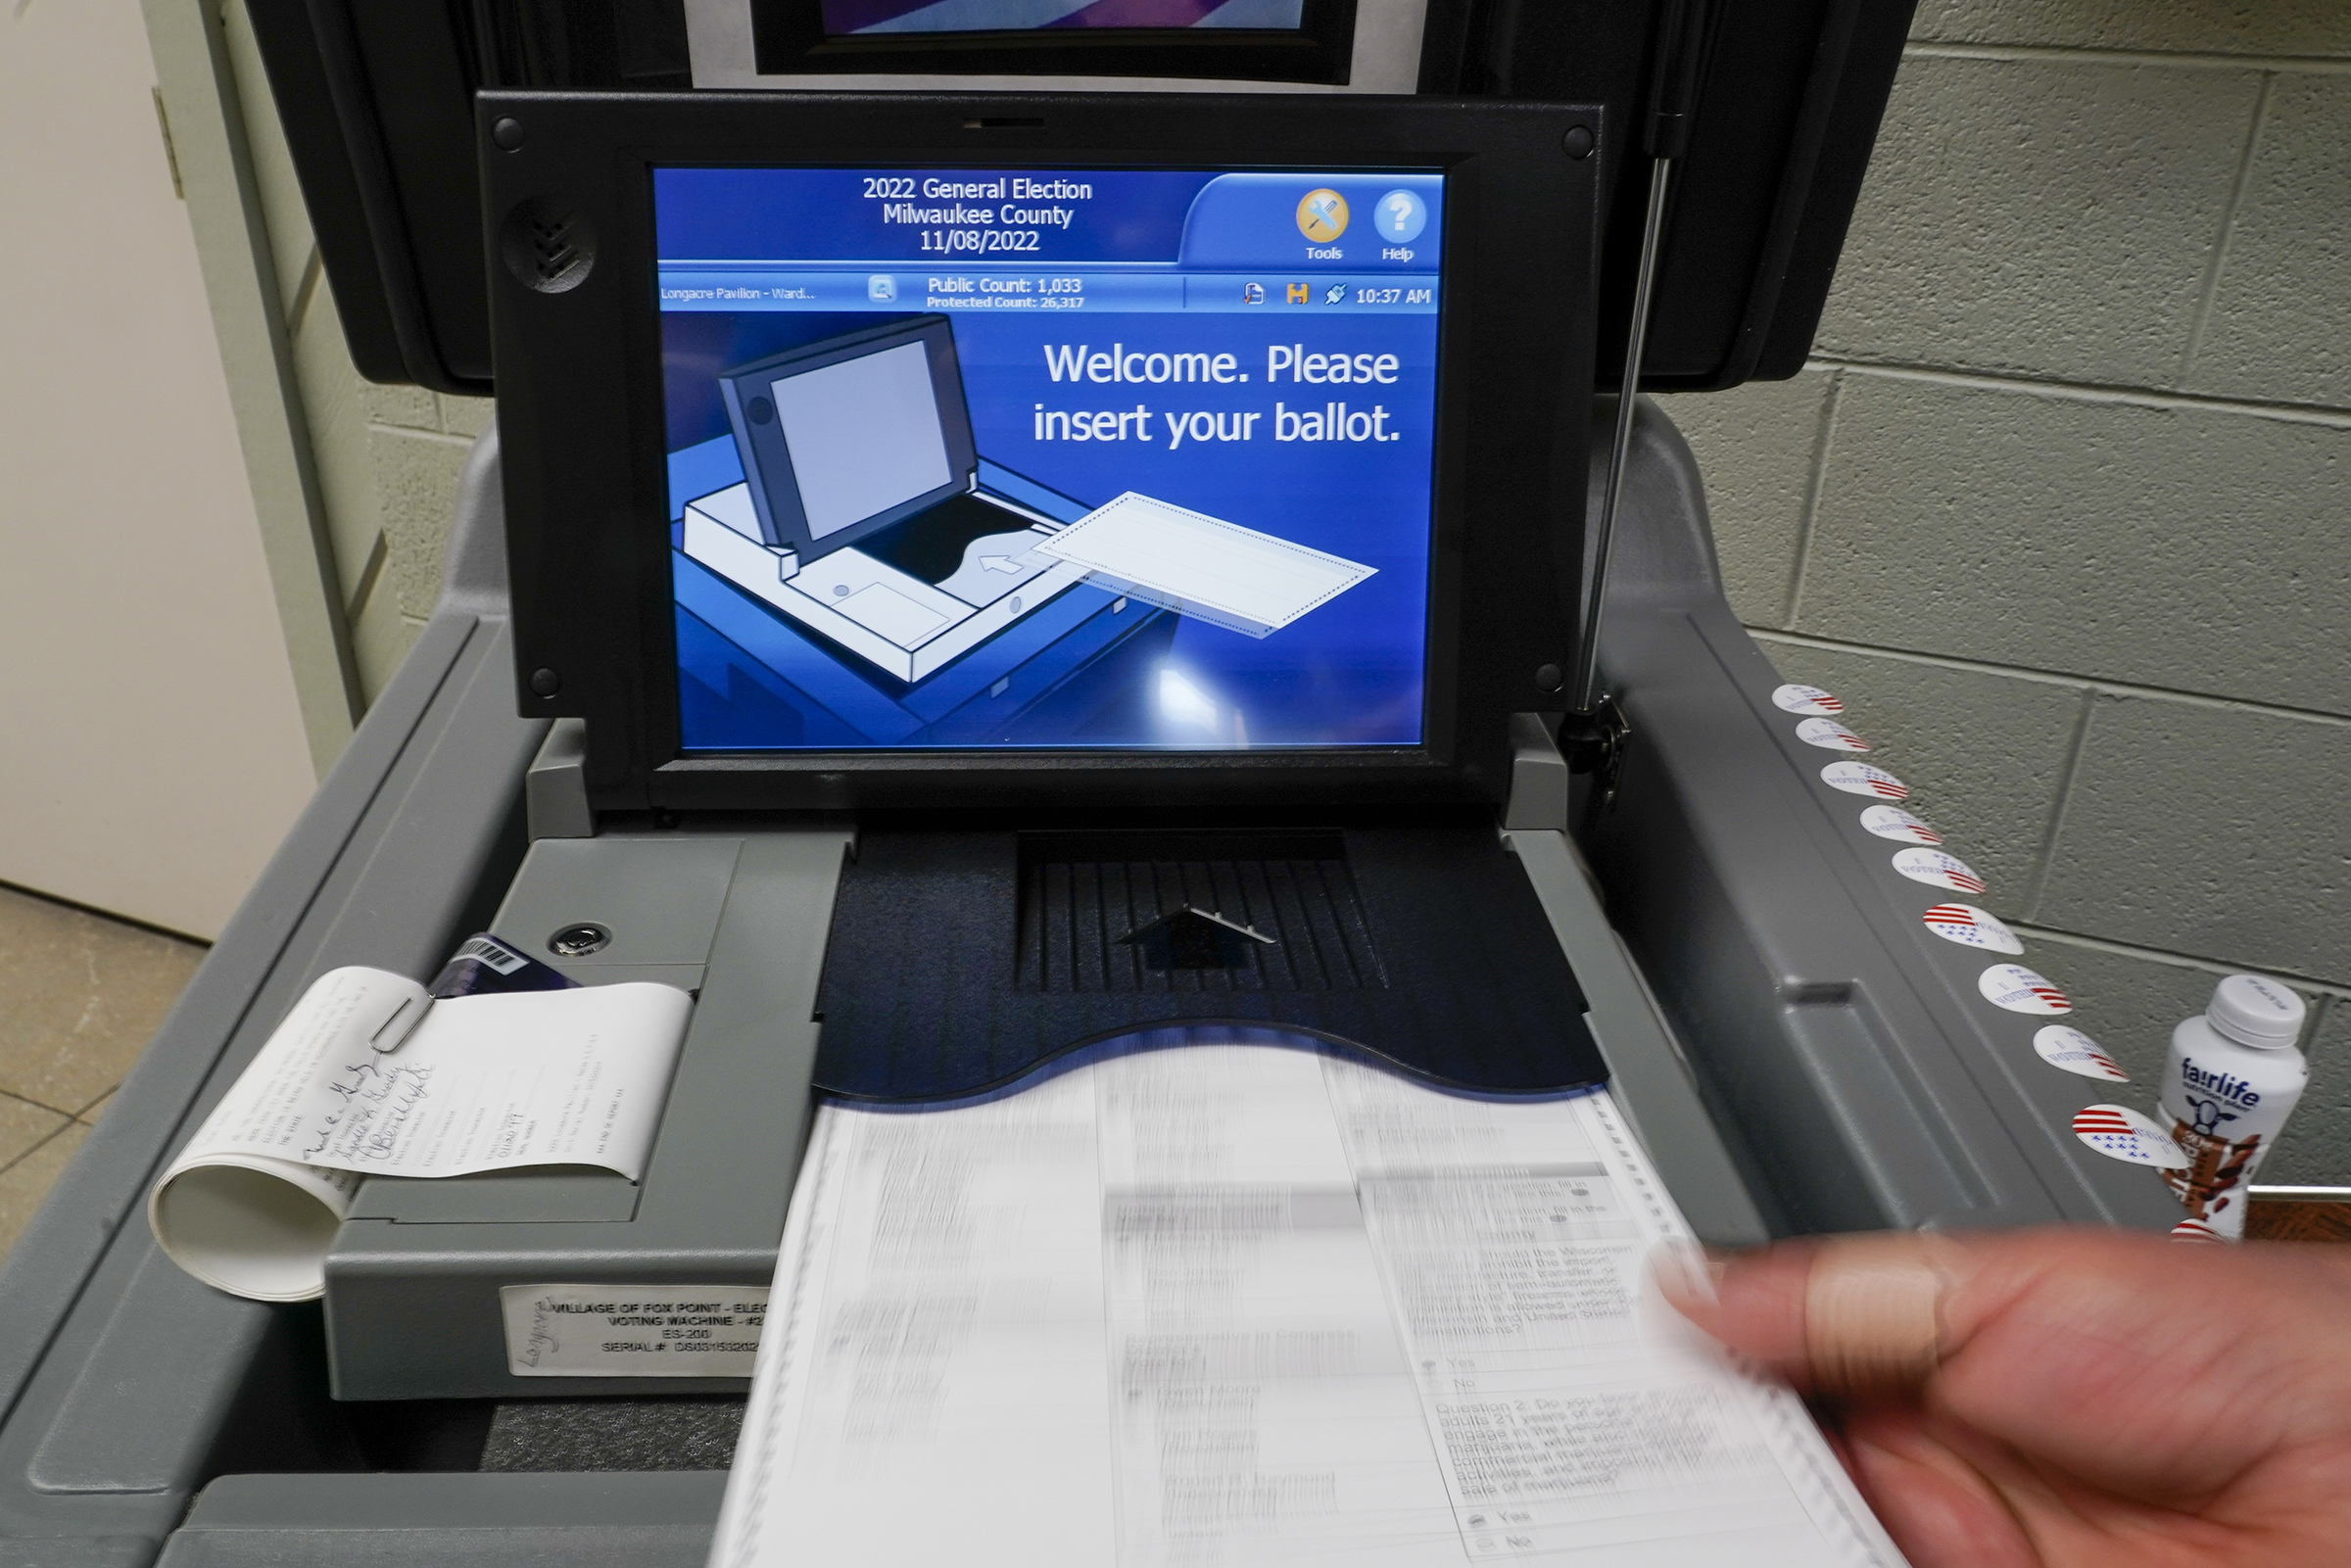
[653,166,1444,752]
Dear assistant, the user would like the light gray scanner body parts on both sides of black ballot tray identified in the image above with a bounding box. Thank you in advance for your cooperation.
[324,717,1763,1399]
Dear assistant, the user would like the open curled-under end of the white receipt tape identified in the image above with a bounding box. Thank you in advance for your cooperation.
[148,1155,362,1303]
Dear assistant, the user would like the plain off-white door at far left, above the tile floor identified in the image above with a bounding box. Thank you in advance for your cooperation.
[0,0,312,935]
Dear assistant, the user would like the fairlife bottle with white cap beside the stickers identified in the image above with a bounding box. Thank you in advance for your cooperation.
[2158,975,2311,1237]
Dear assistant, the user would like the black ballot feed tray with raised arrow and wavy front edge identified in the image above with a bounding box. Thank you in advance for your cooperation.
[816,816,1608,1100]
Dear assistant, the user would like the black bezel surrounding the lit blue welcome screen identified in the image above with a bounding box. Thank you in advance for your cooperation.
[480,94,1599,809]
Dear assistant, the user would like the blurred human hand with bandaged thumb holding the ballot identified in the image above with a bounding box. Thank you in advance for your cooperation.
[1659,1227,2351,1568]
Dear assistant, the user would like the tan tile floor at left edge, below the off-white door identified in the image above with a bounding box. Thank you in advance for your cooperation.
[0,886,205,1258]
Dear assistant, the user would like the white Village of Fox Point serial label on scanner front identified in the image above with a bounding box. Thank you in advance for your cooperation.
[499,1286,766,1378]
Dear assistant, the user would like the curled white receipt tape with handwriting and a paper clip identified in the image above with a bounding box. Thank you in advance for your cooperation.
[148,969,694,1300]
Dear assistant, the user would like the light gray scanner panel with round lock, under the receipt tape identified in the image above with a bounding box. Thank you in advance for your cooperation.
[327,818,853,1399]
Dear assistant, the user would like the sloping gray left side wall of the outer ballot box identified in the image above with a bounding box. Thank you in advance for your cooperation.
[0,439,546,1563]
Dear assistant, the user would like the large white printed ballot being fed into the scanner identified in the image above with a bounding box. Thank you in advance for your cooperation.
[710,1044,1902,1568]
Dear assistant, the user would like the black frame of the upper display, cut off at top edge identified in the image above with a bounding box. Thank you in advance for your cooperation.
[750,0,1357,87]
